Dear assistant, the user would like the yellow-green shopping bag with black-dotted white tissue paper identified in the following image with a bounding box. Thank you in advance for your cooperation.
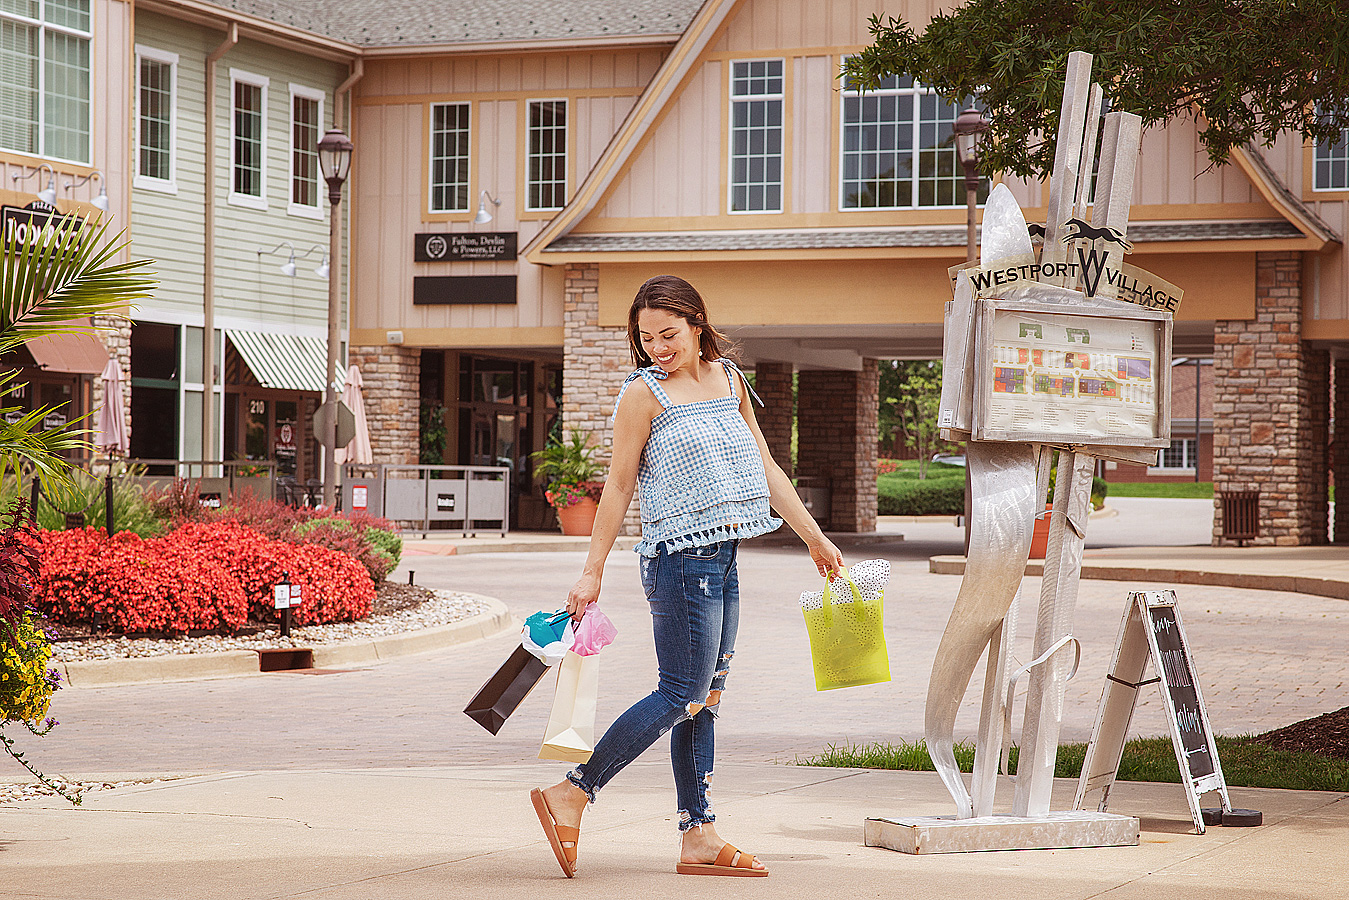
[801,560,890,691]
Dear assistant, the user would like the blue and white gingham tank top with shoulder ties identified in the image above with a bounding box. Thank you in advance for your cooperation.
[614,359,782,556]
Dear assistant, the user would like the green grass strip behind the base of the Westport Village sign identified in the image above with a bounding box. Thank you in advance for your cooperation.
[796,737,1349,792]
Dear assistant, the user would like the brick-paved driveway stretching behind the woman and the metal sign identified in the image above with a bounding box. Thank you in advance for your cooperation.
[27,541,1349,779]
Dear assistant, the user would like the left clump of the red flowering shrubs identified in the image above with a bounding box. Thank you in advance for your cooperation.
[34,529,248,634]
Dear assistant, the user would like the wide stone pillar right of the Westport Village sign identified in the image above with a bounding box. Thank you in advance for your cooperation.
[1213,251,1330,546]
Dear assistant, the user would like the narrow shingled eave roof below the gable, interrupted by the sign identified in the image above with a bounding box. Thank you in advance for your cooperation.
[544,220,1302,252]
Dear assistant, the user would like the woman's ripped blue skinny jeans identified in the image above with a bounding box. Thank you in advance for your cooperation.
[567,541,741,831]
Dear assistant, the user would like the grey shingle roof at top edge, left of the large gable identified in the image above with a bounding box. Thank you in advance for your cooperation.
[209,0,701,47]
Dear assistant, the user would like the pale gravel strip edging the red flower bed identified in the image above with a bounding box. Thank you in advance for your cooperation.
[51,591,499,663]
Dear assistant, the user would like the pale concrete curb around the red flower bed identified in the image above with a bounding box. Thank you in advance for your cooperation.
[54,594,515,688]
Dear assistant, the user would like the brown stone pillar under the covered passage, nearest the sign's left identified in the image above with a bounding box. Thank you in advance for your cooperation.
[796,359,881,532]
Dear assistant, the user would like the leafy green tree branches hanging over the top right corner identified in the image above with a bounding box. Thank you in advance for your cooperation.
[843,0,1349,177]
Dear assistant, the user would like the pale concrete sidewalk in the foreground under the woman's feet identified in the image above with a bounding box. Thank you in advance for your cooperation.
[0,761,1349,900]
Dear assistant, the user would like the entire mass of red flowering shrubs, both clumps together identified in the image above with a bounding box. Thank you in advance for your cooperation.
[34,522,375,634]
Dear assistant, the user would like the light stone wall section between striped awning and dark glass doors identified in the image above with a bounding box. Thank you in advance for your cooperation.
[349,344,421,466]
